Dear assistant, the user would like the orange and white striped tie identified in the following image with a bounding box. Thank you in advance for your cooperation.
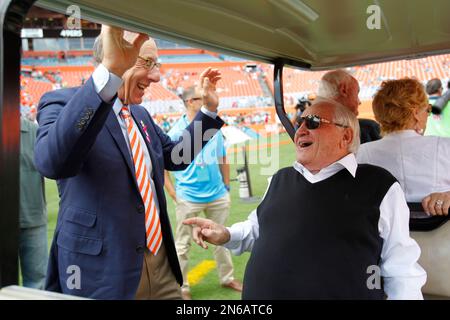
[121,106,162,255]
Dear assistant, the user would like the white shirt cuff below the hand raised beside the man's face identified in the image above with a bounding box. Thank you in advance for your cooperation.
[92,64,123,102]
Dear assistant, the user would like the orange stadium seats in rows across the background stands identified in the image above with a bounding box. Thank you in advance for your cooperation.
[22,50,450,113]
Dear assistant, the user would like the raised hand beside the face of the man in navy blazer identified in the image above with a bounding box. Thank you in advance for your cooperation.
[101,25,149,77]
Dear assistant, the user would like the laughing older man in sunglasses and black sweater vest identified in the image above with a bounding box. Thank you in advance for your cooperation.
[185,100,426,299]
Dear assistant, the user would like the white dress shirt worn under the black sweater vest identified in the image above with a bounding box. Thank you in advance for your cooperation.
[224,153,426,299]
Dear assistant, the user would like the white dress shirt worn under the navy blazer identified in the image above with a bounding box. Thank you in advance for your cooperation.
[92,64,217,212]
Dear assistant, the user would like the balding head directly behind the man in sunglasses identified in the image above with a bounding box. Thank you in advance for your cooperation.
[318,69,361,115]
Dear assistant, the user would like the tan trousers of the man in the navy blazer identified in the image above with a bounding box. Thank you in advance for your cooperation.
[136,242,181,300]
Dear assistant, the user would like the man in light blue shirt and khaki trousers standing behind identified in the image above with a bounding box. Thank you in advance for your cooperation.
[165,87,242,299]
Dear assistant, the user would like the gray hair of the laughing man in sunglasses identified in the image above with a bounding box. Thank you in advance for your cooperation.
[312,97,360,154]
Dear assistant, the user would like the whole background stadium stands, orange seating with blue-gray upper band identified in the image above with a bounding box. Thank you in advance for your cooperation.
[22,48,450,113]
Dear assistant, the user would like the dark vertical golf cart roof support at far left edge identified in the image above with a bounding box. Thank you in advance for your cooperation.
[0,0,34,288]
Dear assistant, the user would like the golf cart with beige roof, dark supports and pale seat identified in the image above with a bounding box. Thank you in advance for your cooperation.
[0,0,450,296]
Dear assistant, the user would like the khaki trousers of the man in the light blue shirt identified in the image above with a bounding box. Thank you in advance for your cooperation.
[175,193,234,290]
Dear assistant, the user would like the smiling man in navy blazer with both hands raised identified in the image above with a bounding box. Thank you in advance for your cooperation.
[35,26,223,299]
